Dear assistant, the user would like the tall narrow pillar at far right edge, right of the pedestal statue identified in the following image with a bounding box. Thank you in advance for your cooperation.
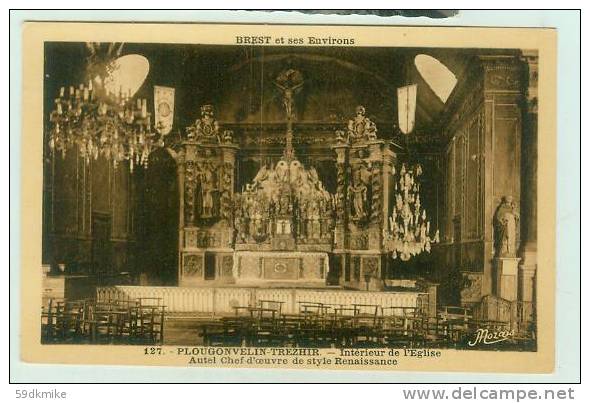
[518,51,539,322]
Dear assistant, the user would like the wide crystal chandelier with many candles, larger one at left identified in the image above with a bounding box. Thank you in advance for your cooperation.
[49,64,164,172]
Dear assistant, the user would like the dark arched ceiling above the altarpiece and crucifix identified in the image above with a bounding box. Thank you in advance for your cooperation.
[46,43,488,139]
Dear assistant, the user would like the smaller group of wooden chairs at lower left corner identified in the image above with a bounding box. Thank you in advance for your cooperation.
[41,298,166,344]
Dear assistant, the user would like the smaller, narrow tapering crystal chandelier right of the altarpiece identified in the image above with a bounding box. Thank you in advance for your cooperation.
[383,164,439,261]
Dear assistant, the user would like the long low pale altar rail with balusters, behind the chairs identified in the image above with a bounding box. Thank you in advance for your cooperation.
[96,286,428,314]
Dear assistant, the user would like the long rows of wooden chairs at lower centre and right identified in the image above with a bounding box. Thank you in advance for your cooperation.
[200,301,532,348]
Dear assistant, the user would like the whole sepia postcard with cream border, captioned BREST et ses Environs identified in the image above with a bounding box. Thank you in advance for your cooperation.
[20,22,556,373]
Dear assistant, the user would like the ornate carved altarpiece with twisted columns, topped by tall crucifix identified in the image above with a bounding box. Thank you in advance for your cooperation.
[178,70,395,289]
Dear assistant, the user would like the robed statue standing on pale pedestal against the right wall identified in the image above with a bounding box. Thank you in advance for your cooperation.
[494,196,520,257]
